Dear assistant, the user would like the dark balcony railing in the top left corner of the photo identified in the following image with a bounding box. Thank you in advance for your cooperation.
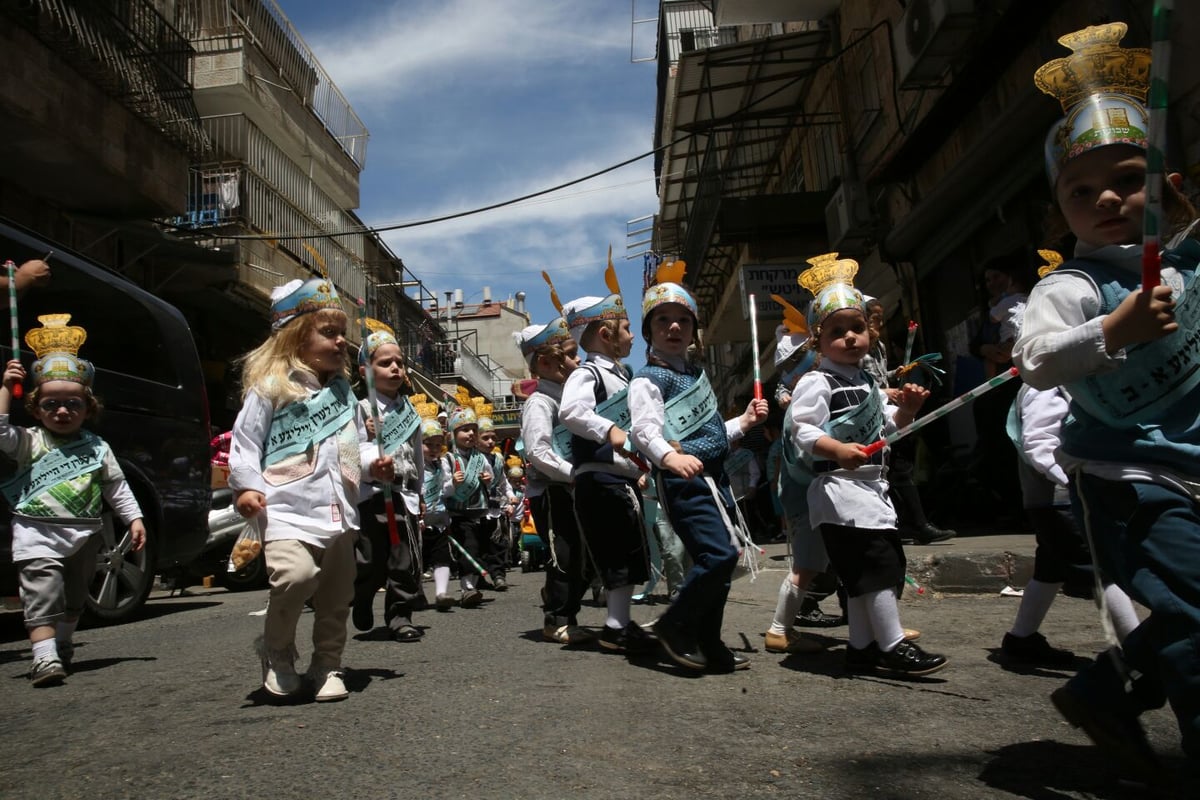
[0,0,208,157]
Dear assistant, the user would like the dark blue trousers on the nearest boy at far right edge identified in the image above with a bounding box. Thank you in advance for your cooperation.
[1076,475,1200,759]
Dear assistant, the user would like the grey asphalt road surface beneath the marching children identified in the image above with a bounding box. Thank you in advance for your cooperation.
[0,546,1182,800]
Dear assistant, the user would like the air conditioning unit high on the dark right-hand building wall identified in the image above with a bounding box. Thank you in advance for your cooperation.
[892,0,976,89]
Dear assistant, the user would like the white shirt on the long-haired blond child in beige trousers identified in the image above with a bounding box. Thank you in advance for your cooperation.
[229,373,379,547]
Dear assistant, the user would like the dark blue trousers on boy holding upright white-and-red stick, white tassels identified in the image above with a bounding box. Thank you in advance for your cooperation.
[659,471,738,650]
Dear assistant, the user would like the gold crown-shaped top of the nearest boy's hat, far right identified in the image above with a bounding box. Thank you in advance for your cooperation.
[1033,23,1150,114]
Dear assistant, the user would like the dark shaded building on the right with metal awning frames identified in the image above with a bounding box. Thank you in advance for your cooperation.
[650,0,1200,449]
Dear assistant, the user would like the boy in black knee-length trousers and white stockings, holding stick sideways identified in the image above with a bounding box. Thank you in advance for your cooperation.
[788,253,946,676]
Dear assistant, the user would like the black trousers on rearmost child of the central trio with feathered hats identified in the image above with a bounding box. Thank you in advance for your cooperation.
[529,483,590,627]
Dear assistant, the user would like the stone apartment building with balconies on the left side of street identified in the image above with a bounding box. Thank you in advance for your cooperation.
[0,0,477,426]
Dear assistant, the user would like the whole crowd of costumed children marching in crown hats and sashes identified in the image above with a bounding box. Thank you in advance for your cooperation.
[7,15,1200,780]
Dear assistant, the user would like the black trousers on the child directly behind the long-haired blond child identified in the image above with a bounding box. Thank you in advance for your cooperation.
[354,494,424,630]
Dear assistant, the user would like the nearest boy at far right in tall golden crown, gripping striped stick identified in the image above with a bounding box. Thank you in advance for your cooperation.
[1013,23,1200,789]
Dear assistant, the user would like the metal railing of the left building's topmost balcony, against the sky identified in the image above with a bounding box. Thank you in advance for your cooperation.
[179,0,370,169]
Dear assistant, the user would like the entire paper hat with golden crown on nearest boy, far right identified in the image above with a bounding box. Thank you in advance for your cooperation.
[1033,23,1151,187]
